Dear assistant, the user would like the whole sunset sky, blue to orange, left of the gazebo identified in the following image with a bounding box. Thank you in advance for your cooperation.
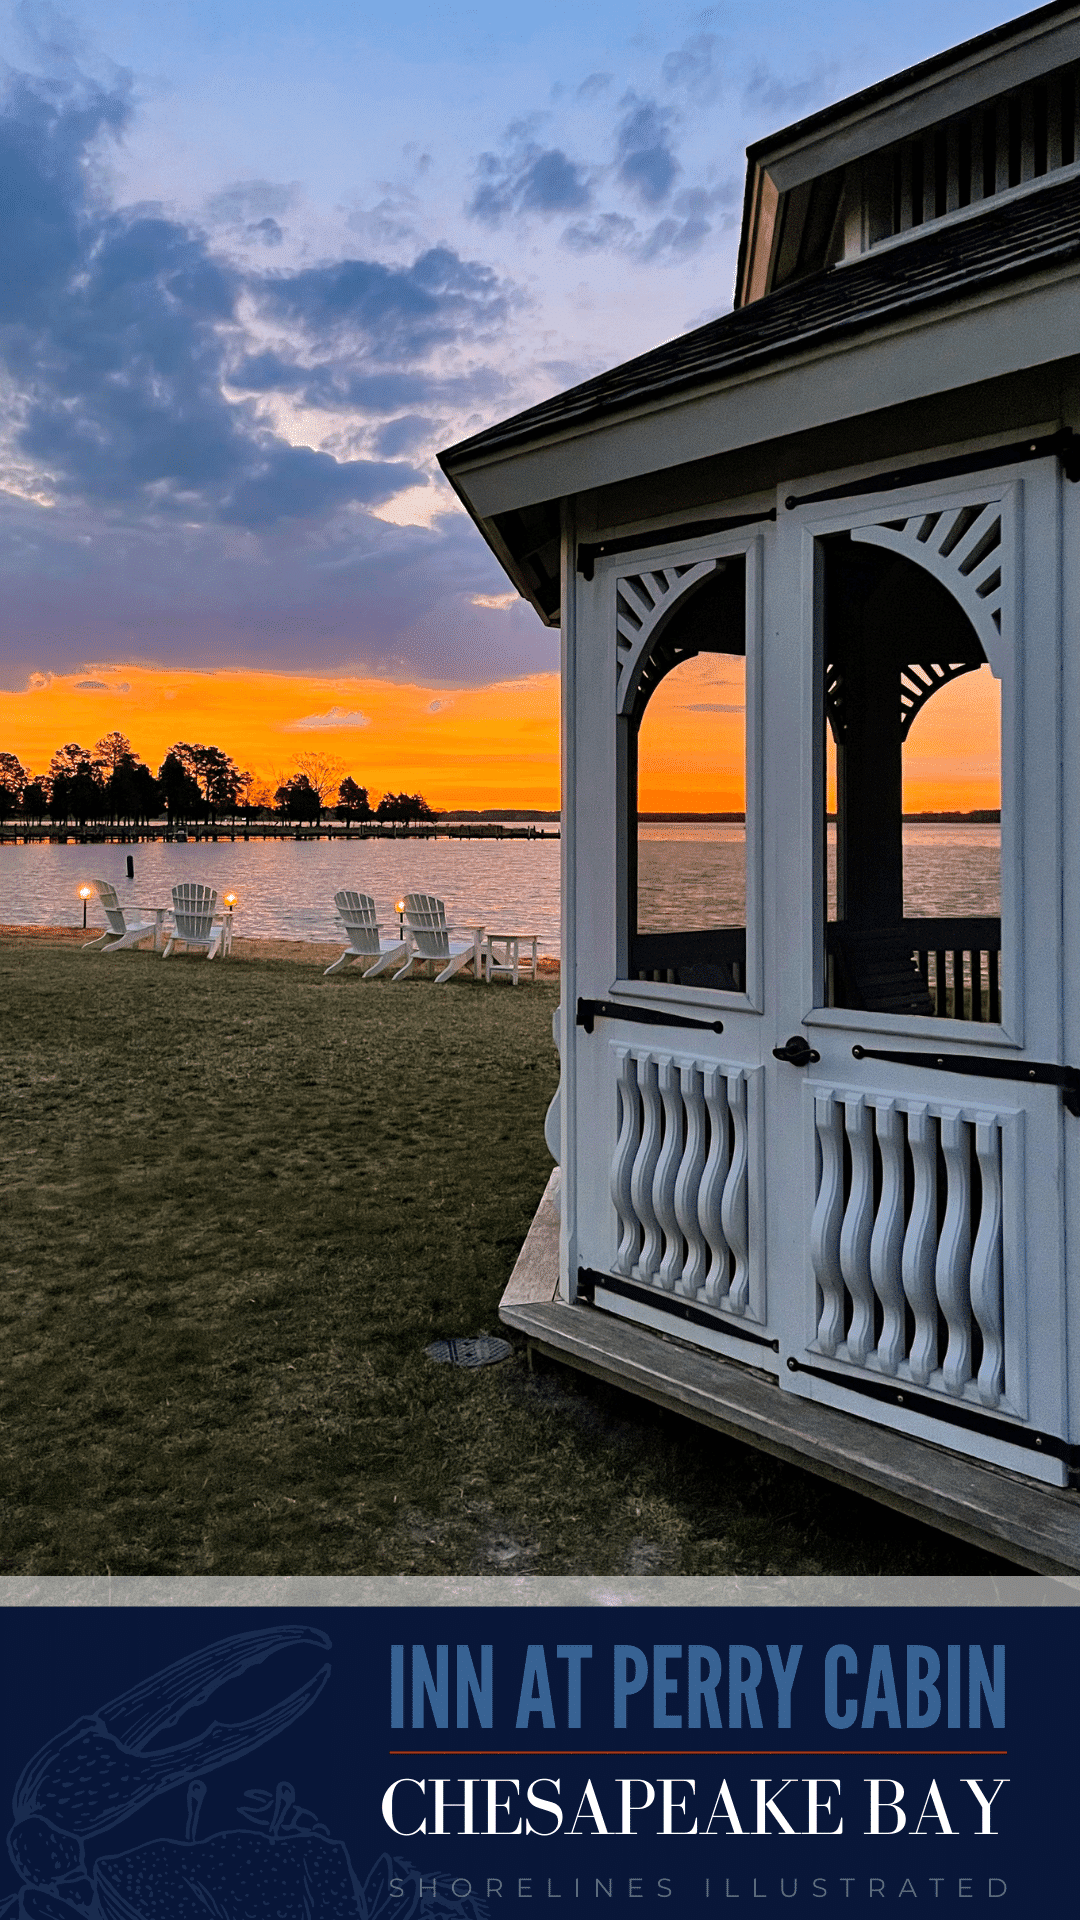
[0,0,1013,806]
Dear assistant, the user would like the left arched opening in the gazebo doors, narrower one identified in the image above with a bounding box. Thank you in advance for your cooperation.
[621,557,746,993]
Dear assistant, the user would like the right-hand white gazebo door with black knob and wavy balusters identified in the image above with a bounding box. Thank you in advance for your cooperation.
[765,461,1060,1484]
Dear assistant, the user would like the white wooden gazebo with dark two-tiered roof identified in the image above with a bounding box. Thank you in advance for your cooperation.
[442,4,1080,1571]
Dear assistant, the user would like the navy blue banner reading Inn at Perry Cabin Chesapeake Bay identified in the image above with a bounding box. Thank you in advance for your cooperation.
[0,1607,1080,1920]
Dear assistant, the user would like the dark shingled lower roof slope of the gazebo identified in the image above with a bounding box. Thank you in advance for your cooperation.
[440,177,1080,472]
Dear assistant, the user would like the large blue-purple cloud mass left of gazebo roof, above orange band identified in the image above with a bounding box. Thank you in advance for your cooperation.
[0,61,557,691]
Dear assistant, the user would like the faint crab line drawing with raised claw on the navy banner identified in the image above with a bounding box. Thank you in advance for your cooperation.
[0,1626,484,1920]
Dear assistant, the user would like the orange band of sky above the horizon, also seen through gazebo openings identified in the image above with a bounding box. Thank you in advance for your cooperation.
[0,655,1001,812]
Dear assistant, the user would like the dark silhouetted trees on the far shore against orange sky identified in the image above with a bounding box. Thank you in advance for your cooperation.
[0,732,434,828]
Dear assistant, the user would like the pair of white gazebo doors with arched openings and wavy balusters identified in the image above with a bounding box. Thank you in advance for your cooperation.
[565,445,1080,1482]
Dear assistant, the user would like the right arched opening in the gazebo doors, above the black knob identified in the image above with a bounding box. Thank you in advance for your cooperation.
[822,534,1001,1021]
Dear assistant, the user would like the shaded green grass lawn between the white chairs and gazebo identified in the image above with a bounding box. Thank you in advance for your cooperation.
[0,943,999,1574]
